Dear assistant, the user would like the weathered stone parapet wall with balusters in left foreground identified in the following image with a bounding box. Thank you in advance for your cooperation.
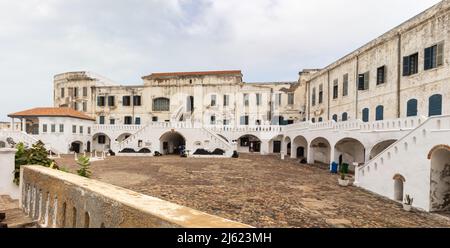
[21,166,250,228]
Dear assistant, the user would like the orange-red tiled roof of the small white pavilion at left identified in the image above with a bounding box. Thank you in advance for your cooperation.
[8,108,95,121]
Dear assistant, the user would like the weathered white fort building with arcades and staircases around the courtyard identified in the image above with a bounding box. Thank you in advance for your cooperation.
[0,0,450,211]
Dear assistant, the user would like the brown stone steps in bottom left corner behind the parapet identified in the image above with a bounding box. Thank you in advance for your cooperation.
[0,195,37,228]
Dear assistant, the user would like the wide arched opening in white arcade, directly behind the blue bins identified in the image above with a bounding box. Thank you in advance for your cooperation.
[332,138,366,166]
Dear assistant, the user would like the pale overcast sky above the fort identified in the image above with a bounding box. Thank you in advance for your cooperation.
[0,0,439,120]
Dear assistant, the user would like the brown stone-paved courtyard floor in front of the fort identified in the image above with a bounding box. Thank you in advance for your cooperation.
[57,155,450,227]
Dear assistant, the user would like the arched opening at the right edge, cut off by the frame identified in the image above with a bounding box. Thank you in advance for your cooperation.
[430,145,450,212]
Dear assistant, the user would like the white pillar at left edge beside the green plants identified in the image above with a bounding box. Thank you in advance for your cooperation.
[0,148,20,199]
